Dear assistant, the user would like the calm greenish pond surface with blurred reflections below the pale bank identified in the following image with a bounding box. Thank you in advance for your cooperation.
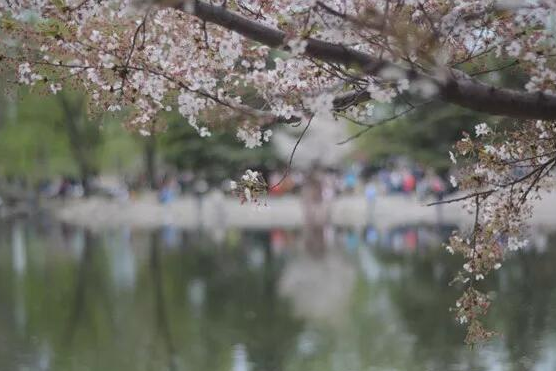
[0,220,556,371]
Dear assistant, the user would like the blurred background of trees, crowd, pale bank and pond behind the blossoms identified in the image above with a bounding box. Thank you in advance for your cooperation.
[0,84,556,371]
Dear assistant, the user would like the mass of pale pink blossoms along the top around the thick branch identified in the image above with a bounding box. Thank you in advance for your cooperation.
[0,0,556,132]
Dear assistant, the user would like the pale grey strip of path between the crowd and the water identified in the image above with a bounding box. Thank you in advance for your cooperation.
[50,193,556,230]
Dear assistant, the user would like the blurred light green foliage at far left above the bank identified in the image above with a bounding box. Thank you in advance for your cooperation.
[0,89,139,183]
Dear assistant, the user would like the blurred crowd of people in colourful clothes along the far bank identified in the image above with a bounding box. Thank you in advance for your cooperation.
[30,160,454,203]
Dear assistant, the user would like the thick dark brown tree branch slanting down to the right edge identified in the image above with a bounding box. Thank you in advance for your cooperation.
[181,0,556,120]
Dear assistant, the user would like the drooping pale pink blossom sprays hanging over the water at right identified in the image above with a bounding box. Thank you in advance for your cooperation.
[447,121,556,343]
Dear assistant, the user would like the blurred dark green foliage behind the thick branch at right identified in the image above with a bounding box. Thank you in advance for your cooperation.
[355,53,527,172]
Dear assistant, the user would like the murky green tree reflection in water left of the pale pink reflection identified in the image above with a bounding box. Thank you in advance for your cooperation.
[0,227,300,371]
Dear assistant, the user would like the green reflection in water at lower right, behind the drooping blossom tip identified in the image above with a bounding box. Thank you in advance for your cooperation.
[286,234,556,371]
